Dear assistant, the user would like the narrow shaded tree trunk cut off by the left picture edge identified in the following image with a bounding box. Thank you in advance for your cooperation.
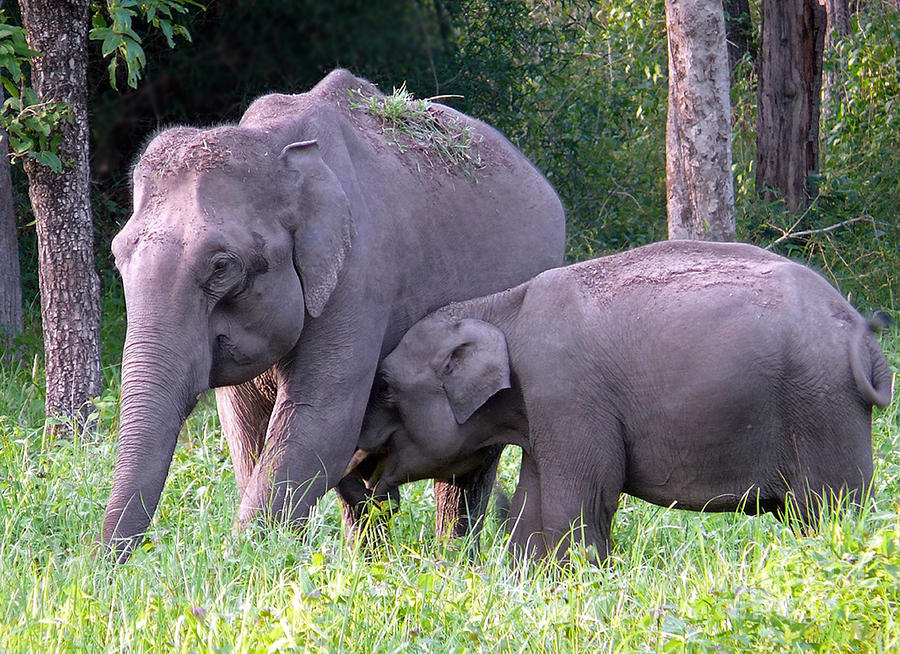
[0,116,22,363]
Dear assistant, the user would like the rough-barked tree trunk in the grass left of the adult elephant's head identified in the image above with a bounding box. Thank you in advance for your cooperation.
[21,0,101,432]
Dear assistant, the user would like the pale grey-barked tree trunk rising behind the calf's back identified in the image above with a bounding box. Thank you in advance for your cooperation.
[666,0,735,241]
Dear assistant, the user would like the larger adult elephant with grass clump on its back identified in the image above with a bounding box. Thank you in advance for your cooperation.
[101,70,564,559]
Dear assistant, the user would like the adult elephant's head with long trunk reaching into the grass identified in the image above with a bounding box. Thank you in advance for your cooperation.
[101,127,352,557]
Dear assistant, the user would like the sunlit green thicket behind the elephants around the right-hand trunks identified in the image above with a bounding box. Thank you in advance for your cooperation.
[426,0,900,308]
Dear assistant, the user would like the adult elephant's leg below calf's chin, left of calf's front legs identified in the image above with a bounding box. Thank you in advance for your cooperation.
[434,445,503,553]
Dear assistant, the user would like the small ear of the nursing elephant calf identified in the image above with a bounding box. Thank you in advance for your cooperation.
[438,318,510,425]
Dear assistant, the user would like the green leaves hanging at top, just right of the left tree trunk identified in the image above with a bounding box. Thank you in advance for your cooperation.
[88,0,205,89]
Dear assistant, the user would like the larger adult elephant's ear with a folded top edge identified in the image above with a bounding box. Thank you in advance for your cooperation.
[281,141,353,318]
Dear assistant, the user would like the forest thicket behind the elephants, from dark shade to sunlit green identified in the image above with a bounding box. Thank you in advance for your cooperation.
[5,0,900,326]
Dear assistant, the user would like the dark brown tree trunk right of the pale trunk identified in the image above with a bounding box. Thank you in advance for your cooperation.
[756,0,825,212]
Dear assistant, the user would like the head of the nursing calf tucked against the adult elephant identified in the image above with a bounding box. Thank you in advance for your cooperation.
[347,315,520,493]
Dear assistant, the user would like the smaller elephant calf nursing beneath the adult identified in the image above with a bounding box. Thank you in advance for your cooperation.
[360,241,891,560]
